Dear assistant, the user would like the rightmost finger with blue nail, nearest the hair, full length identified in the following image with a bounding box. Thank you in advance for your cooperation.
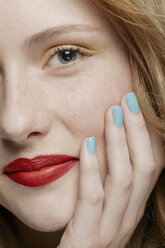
[118,93,158,232]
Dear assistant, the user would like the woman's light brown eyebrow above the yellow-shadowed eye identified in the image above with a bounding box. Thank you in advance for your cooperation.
[23,24,101,49]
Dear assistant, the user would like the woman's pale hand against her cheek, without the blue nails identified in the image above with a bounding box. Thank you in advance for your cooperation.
[58,94,164,248]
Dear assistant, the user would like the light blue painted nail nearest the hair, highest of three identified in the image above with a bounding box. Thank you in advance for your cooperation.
[125,92,139,114]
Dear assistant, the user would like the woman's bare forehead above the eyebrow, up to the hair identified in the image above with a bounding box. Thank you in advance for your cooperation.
[0,0,116,55]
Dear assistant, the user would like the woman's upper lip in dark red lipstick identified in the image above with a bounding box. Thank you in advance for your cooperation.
[3,155,78,173]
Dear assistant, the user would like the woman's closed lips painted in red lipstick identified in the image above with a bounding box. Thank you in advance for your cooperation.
[3,155,79,187]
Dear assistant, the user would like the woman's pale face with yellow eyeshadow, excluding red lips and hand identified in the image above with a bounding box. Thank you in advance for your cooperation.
[0,0,132,232]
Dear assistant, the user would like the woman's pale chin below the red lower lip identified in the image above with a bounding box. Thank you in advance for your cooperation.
[1,164,78,232]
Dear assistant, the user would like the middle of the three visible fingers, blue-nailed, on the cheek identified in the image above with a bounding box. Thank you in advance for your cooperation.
[101,106,132,240]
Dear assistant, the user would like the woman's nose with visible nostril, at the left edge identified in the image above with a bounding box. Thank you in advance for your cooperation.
[0,70,50,145]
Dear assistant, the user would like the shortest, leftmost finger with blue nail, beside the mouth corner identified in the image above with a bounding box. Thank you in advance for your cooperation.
[66,137,104,240]
